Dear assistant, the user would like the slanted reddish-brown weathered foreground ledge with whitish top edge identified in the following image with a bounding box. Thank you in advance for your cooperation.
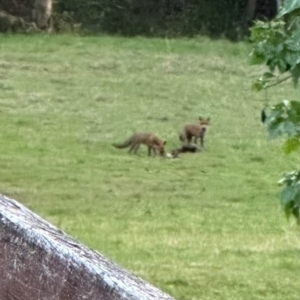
[0,195,173,300]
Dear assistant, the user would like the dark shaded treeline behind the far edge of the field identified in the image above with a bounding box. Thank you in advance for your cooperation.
[54,0,277,40]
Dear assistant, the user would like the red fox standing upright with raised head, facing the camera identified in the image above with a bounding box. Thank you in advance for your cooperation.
[179,117,210,148]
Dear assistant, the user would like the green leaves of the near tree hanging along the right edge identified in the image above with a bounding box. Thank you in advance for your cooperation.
[251,0,300,224]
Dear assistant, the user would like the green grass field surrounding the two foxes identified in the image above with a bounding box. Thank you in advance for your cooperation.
[0,35,300,300]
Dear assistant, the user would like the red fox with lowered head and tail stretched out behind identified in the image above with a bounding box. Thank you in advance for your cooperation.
[113,132,167,156]
